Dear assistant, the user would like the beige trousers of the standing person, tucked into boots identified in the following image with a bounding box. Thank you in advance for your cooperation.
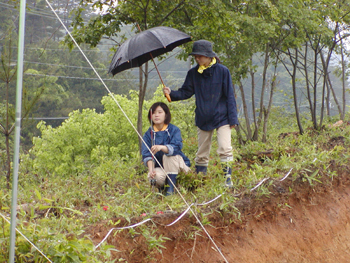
[195,124,233,166]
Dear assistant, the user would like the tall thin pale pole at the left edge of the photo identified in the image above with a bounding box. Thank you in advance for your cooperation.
[9,0,26,263]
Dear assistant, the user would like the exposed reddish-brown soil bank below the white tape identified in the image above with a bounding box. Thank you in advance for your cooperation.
[88,165,350,263]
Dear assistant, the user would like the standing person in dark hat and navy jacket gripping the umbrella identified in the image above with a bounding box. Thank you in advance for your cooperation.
[163,40,238,187]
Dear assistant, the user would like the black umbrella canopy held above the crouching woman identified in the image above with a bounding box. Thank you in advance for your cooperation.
[108,26,191,75]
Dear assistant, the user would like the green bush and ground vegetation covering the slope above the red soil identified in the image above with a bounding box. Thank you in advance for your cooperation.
[0,87,350,262]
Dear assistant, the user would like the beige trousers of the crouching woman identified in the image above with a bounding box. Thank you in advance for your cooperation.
[148,155,190,187]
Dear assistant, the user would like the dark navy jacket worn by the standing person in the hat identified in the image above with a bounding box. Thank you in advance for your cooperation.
[170,63,238,131]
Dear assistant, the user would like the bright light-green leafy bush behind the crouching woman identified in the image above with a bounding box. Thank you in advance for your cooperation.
[27,85,195,176]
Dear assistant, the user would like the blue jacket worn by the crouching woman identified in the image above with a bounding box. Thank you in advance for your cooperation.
[141,123,191,167]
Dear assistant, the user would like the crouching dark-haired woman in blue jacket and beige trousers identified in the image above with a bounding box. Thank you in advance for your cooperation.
[142,102,191,195]
